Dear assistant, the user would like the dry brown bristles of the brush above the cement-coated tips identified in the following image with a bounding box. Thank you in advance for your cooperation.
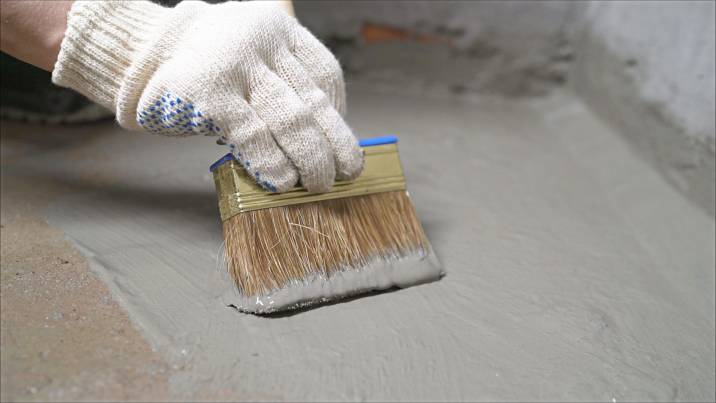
[224,191,430,304]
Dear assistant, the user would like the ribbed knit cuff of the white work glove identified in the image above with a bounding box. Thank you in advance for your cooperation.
[52,0,168,117]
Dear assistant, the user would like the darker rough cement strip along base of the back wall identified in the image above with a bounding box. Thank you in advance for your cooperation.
[330,33,572,97]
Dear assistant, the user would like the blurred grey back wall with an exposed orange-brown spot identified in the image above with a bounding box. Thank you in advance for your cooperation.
[296,1,577,96]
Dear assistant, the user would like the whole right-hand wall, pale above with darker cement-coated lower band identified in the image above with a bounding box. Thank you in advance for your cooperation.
[570,2,716,215]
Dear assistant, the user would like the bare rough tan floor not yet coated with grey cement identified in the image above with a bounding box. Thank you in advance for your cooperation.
[0,144,169,401]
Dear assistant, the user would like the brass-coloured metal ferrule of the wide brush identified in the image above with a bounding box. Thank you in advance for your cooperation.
[213,144,405,221]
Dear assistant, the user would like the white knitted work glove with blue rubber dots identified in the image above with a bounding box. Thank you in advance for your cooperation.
[52,0,363,192]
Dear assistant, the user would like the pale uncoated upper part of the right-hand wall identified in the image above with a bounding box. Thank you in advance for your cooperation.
[577,1,716,145]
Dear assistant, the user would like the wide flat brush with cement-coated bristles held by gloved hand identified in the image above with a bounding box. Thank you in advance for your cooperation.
[210,136,443,314]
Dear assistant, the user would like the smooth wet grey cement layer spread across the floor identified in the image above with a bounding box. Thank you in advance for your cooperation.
[2,88,715,401]
